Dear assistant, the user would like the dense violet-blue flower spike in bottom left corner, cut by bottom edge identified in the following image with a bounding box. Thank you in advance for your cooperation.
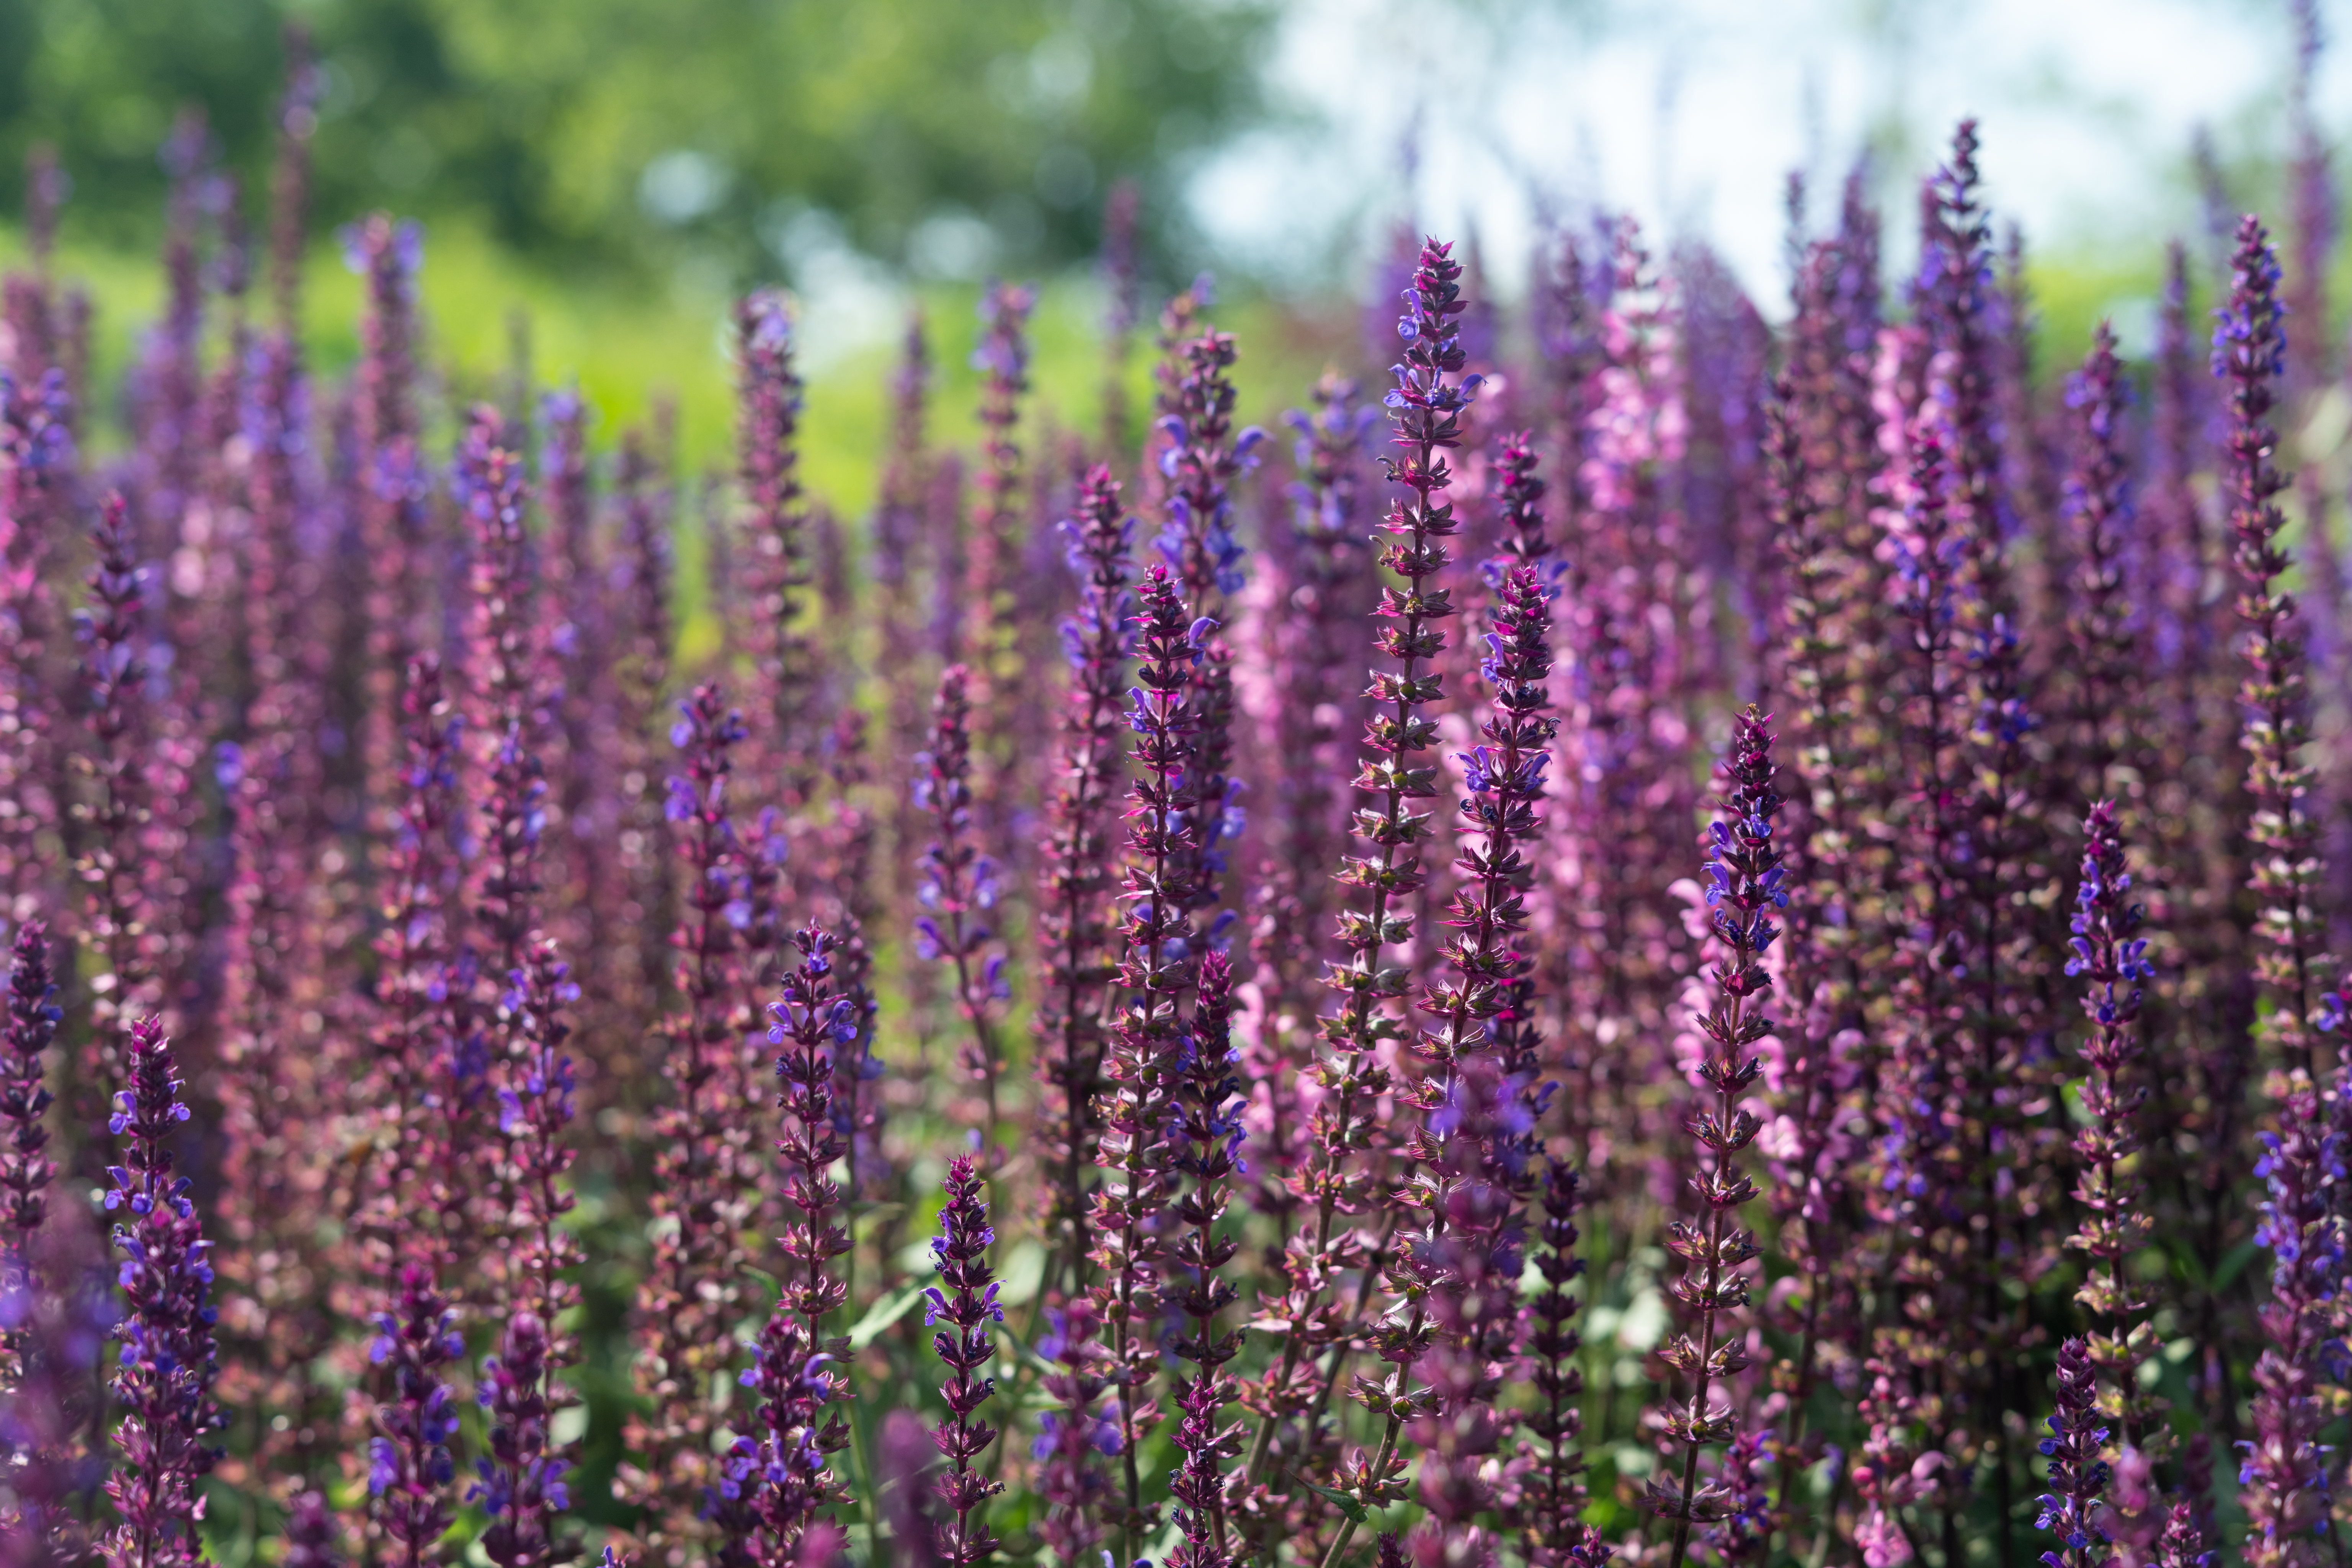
[99,1018,228,1568]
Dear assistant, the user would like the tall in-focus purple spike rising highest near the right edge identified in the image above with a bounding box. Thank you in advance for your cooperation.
[2213,214,2326,1072]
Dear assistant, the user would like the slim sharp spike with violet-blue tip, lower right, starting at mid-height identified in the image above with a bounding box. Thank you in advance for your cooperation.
[2065,799,2159,1448]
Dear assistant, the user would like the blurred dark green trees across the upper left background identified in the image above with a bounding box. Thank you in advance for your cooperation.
[0,0,1272,282]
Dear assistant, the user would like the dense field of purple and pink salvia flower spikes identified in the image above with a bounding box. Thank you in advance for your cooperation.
[0,43,2352,1568]
